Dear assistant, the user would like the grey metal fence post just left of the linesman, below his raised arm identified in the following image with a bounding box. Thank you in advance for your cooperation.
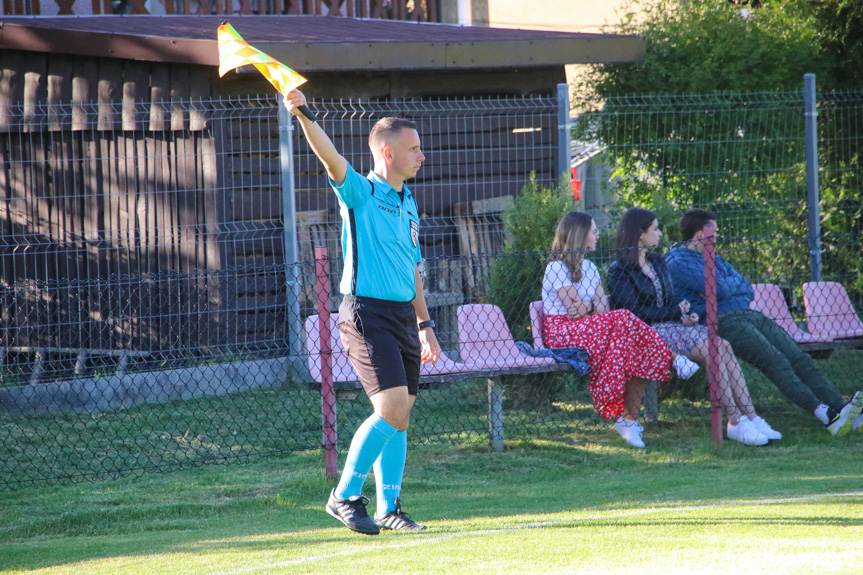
[279,99,312,382]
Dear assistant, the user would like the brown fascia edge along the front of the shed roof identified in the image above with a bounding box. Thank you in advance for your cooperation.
[0,22,645,72]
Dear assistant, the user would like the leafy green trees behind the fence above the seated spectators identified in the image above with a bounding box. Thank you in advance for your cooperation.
[574,0,863,290]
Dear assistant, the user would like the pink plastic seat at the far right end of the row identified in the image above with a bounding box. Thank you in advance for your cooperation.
[803,282,863,339]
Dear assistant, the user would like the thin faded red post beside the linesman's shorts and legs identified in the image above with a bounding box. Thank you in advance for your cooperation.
[307,248,339,481]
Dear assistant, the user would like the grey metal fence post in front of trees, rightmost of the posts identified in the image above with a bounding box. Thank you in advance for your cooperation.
[803,74,821,282]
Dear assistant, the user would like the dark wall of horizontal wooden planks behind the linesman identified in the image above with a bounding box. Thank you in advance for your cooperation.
[217,97,557,336]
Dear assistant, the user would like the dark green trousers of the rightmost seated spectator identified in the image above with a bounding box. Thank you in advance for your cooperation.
[718,309,845,413]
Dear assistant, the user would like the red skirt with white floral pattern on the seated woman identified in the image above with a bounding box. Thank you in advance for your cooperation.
[543,309,671,419]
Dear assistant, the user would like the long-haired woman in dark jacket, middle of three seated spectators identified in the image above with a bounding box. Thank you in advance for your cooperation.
[608,208,782,445]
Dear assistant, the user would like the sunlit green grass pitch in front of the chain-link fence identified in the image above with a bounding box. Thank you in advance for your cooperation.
[0,410,863,575]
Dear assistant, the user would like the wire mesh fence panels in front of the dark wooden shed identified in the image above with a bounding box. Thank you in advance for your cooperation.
[0,93,559,385]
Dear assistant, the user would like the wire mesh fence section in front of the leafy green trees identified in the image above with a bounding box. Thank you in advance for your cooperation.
[574,86,863,306]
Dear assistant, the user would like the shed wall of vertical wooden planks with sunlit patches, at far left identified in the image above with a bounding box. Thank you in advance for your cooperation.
[0,50,226,351]
